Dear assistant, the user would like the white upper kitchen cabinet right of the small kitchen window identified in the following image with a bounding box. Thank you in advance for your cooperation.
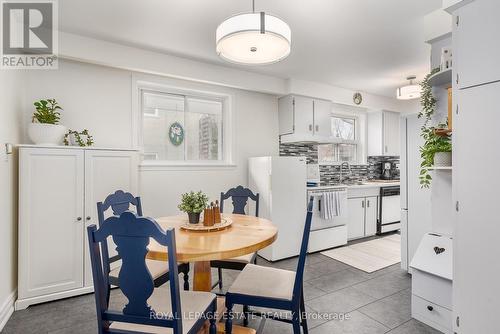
[368,111,401,156]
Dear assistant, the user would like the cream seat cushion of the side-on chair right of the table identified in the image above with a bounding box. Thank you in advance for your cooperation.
[228,264,295,300]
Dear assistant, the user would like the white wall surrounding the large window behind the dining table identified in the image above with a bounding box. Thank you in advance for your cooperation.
[24,61,279,216]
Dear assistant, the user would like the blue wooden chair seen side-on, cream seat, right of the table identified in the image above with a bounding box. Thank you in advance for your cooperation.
[226,198,313,334]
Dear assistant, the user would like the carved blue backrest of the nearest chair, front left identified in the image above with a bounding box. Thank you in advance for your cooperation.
[87,211,182,333]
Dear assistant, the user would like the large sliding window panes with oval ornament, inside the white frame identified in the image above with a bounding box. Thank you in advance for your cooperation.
[141,90,224,164]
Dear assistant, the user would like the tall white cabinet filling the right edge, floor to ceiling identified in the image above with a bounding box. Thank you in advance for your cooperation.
[453,0,500,334]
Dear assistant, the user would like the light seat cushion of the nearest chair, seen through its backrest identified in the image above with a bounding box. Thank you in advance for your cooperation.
[110,285,217,334]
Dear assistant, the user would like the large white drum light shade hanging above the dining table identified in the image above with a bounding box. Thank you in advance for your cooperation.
[216,12,292,65]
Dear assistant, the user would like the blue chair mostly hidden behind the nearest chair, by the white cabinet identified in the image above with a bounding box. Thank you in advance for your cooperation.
[97,190,189,291]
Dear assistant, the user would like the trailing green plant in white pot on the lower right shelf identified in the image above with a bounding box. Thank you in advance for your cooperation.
[420,123,452,188]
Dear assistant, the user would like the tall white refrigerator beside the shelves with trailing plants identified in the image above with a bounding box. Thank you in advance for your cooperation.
[400,114,432,271]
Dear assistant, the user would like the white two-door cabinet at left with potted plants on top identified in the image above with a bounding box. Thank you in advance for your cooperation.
[16,145,138,310]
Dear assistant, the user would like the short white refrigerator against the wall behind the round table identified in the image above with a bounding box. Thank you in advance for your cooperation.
[248,156,307,261]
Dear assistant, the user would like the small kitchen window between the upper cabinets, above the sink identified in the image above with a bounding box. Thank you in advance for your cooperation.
[318,116,358,164]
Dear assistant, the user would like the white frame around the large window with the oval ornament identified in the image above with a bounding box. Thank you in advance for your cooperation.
[132,80,236,170]
